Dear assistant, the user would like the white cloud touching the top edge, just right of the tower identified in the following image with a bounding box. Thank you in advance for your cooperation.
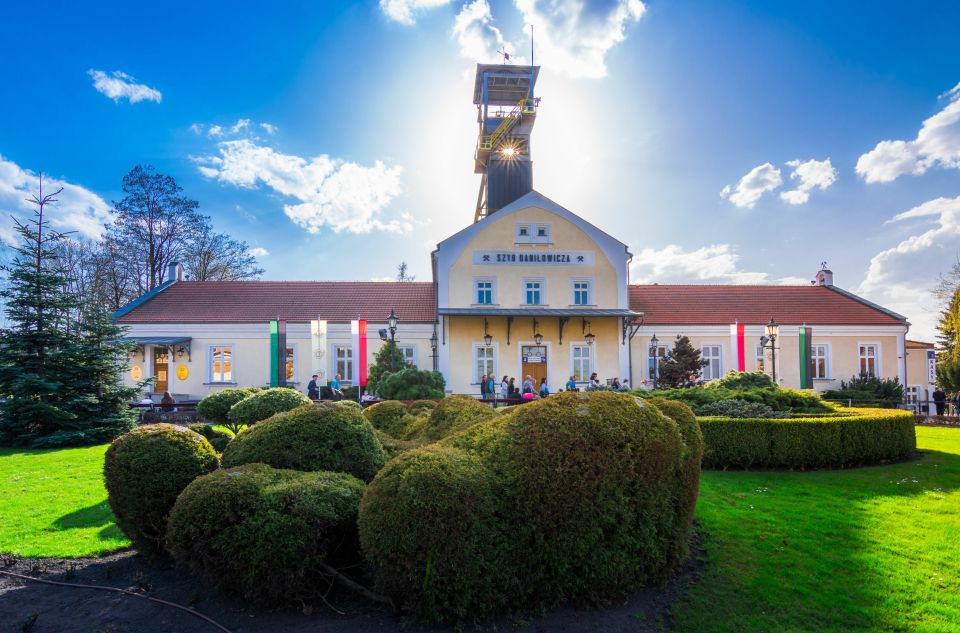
[514,0,646,78]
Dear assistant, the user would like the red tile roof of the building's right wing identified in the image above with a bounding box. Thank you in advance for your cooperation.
[630,284,903,325]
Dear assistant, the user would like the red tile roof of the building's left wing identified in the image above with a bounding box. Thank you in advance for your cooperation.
[119,281,436,324]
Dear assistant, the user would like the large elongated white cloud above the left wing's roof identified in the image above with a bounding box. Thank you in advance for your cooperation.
[194,139,413,233]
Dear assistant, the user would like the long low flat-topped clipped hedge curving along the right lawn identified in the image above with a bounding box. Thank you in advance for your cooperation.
[699,408,917,469]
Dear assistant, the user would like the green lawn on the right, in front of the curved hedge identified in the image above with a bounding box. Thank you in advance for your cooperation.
[671,428,960,632]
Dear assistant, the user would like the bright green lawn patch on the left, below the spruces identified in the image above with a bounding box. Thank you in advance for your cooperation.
[0,444,130,557]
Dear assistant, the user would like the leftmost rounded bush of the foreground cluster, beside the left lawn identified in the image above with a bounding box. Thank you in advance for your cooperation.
[103,424,220,555]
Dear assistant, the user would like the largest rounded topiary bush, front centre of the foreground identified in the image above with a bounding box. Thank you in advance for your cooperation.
[359,392,700,621]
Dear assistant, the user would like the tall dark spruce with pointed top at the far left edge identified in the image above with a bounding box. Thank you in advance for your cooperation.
[0,181,77,444]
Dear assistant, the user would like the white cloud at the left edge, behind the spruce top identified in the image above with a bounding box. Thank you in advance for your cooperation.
[0,155,113,244]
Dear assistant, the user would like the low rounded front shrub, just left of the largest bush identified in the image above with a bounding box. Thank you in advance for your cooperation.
[167,464,364,605]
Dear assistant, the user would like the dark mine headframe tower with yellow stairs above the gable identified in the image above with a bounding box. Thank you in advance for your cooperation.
[473,64,540,222]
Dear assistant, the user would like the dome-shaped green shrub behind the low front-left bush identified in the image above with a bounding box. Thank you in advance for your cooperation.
[223,404,386,481]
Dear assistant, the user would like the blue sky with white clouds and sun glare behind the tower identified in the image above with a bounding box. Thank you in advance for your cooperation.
[0,0,960,338]
